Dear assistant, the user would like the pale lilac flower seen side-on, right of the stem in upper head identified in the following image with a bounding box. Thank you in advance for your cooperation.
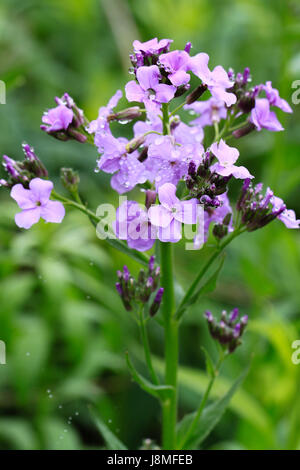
[184,97,227,127]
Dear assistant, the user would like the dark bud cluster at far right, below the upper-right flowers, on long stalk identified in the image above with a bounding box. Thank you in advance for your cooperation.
[236,179,286,232]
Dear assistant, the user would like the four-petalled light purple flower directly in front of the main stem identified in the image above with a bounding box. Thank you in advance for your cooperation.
[148,183,197,243]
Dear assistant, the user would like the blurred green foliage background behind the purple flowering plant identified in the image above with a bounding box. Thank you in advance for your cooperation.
[0,0,300,449]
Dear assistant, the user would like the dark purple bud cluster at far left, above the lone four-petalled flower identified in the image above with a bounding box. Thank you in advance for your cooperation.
[0,143,48,188]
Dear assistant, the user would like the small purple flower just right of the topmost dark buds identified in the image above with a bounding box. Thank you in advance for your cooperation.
[159,51,190,87]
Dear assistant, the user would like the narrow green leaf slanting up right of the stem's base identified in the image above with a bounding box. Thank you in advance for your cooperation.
[177,367,249,449]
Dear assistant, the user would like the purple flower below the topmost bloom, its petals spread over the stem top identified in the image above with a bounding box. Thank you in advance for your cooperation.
[125,65,176,109]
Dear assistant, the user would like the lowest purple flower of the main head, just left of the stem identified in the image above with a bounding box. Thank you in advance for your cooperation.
[113,201,156,251]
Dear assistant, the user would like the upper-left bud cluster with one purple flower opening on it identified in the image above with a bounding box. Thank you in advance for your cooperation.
[40,93,89,143]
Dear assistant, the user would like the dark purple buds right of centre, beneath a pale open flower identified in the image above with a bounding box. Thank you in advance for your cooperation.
[186,152,232,208]
